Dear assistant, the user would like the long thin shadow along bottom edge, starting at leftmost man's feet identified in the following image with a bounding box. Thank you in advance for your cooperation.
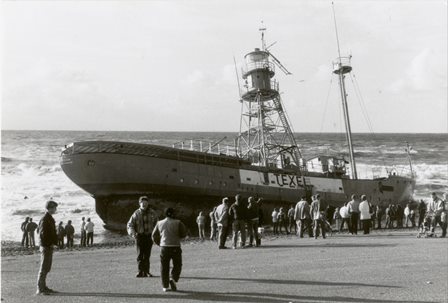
[52,290,430,303]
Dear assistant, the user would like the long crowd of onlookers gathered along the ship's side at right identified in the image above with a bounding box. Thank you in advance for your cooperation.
[196,193,447,242]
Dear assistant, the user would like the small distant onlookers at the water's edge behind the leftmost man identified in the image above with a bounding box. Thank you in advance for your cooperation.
[21,217,95,249]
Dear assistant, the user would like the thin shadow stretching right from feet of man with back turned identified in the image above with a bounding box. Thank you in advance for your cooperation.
[182,277,402,288]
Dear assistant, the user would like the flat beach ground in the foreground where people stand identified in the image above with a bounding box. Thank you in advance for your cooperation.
[1,230,448,303]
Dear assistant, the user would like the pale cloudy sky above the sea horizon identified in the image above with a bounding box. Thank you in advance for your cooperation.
[1,0,448,133]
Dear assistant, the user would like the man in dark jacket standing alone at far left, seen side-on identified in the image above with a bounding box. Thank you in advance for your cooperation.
[36,200,58,295]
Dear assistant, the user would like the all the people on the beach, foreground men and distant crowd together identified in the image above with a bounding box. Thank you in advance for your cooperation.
[30,193,447,295]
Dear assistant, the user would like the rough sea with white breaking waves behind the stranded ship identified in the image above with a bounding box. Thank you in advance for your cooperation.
[1,131,448,243]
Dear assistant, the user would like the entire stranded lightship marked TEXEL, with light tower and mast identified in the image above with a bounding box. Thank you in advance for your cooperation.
[60,28,415,230]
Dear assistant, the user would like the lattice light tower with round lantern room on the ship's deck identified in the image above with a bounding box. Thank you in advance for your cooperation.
[237,26,303,169]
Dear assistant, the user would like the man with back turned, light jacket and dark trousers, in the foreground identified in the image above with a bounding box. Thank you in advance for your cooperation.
[152,208,187,292]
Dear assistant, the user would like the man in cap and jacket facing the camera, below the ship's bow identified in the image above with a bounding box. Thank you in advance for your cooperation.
[127,196,157,278]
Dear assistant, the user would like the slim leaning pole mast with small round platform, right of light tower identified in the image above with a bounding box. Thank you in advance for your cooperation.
[332,3,358,179]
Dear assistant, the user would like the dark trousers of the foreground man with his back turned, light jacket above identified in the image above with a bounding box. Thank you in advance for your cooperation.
[160,246,182,288]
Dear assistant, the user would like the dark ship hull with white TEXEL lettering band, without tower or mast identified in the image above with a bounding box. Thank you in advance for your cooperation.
[61,141,415,230]
